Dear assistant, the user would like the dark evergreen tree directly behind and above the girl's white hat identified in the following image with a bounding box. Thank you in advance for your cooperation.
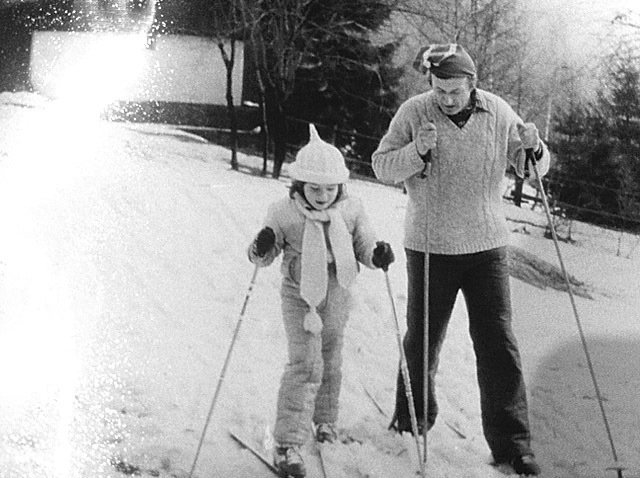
[288,1,403,173]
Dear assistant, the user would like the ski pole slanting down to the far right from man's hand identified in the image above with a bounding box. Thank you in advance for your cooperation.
[526,149,623,478]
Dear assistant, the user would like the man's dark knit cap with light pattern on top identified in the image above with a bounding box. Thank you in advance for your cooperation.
[413,43,476,79]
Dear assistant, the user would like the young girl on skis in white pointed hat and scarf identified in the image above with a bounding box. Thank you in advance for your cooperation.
[249,125,394,478]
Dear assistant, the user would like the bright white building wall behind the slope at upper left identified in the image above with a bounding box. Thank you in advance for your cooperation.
[30,31,244,105]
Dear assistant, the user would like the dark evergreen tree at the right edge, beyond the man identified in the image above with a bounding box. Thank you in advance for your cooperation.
[551,44,640,230]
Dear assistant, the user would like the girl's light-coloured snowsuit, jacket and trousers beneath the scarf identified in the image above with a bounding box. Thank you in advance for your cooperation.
[249,196,375,445]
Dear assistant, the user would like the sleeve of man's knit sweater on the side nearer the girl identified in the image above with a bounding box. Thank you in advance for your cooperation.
[371,101,425,183]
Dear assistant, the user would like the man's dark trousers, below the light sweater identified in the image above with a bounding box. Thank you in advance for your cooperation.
[396,247,531,462]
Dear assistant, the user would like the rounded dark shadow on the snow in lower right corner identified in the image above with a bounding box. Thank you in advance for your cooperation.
[529,336,640,478]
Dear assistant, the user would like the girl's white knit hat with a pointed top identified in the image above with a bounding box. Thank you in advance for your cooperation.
[289,124,349,184]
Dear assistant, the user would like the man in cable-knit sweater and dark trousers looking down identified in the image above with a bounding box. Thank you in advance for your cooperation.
[372,44,549,476]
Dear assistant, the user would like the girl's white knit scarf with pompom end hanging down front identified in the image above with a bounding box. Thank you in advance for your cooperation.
[294,193,358,334]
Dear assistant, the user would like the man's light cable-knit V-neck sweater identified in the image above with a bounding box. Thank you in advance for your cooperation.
[372,89,549,254]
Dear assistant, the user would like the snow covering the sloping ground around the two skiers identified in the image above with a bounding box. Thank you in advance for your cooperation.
[0,93,640,478]
